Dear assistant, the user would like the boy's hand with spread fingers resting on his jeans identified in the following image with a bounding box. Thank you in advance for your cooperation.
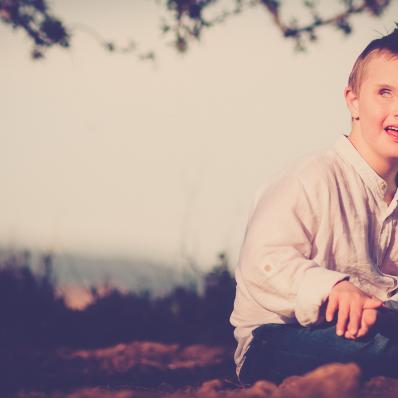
[326,280,383,337]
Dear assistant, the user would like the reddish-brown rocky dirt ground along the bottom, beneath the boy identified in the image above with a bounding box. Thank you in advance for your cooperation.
[9,342,398,398]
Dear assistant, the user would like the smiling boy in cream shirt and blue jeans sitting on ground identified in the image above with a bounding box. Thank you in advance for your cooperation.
[231,28,398,383]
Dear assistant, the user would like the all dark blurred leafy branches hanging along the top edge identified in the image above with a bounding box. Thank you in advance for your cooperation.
[0,0,391,60]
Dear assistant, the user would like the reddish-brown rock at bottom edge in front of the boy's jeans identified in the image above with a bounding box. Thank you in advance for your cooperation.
[272,363,361,398]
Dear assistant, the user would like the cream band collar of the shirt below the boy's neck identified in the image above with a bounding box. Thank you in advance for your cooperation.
[334,134,388,200]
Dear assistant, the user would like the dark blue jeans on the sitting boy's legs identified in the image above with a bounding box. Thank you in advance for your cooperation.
[239,312,398,384]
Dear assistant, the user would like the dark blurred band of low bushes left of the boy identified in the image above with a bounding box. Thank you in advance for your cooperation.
[0,255,235,348]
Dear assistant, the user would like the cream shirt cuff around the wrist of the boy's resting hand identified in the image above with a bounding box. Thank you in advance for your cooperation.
[294,266,350,326]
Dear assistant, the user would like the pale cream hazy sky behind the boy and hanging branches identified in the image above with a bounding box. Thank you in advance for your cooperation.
[0,0,398,296]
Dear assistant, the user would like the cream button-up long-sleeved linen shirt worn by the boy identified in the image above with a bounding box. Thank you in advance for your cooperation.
[231,135,398,374]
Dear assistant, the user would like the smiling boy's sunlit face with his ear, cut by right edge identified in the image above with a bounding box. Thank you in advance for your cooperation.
[345,53,398,163]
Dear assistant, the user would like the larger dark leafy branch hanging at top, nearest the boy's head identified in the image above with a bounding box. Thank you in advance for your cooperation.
[163,0,390,52]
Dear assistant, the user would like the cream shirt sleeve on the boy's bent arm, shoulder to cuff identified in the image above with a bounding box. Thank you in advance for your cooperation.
[239,176,349,326]
